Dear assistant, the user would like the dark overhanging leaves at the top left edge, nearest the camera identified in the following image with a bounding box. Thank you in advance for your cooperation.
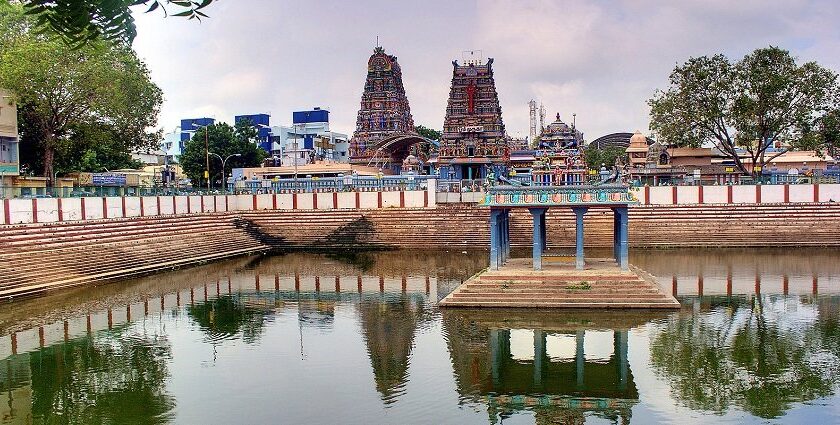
[23,0,213,47]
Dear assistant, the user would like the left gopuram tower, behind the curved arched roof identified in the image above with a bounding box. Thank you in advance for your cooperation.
[350,47,416,165]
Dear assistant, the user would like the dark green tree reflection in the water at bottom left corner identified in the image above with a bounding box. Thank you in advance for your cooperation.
[0,326,175,424]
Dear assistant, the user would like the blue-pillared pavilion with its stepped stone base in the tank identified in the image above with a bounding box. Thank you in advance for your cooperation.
[440,185,679,309]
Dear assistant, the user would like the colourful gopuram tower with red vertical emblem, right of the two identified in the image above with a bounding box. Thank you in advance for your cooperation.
[438,51,509,179]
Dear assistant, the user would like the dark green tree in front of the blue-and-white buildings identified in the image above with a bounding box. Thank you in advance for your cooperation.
[178,120,268,187]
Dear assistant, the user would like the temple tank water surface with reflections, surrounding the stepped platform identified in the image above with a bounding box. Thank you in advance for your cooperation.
[0,249,840,424]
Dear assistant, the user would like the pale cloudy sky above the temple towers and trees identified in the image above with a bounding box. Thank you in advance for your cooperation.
[134,0,840,141]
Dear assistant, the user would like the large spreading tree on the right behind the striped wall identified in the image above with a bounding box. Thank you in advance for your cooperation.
[648,46,840,174]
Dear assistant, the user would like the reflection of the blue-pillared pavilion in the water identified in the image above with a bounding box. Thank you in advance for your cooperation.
[442,310,664,423]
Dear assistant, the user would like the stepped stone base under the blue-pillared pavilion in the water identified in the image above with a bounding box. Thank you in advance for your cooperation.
[439,257,680,309]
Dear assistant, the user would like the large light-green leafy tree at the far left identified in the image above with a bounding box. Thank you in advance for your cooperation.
[0,3,163,178]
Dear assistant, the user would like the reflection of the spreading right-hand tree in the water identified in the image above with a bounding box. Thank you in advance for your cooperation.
[650,295,840,418]
